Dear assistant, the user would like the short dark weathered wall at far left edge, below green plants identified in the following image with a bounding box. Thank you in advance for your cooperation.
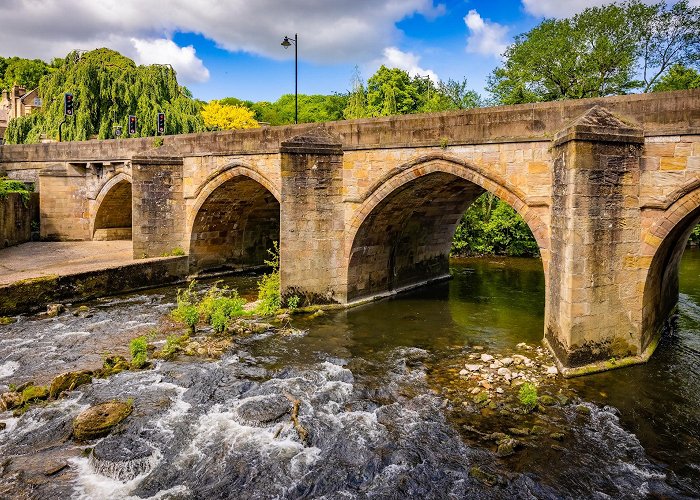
[0,193,39,248]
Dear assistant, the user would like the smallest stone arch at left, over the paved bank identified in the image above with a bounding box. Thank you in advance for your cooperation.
[90,172,132,241]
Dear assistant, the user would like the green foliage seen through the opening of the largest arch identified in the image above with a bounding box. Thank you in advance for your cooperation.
[452,193,539,256]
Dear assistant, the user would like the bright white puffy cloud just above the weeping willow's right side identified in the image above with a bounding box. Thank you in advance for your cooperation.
[131,38,209,83]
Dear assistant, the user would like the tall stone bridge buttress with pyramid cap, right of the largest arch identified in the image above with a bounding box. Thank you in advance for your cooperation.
[545,106,650,375]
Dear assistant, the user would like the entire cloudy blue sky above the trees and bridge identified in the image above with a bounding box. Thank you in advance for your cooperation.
[0,0,688,101]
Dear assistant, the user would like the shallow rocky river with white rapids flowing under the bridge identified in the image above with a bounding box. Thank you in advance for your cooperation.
[0,250,700,499]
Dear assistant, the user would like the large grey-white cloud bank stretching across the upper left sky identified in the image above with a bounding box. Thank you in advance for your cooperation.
[0,0,445,81]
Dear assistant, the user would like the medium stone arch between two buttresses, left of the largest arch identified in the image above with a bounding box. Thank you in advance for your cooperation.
[188,165,280,270]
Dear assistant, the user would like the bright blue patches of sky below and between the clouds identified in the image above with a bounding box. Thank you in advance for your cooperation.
[174,0,541,101]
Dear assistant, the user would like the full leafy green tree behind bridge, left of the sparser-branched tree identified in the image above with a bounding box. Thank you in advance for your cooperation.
[488,4,638,104]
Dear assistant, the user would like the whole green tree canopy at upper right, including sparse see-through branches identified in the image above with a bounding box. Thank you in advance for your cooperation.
[488,0,700,104]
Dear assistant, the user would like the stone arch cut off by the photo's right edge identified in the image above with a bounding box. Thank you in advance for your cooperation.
[641,187,700,349]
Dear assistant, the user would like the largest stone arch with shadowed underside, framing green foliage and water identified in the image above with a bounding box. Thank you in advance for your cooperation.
[346,155,547,301]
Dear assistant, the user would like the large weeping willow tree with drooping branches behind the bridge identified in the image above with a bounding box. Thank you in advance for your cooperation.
[5,49,204,144]
